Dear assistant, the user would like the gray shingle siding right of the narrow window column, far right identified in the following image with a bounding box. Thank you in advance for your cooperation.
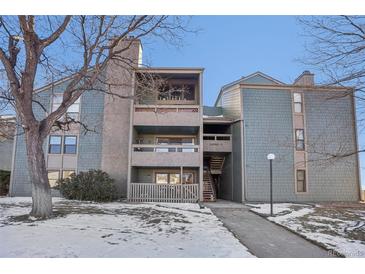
[300,91,359,201]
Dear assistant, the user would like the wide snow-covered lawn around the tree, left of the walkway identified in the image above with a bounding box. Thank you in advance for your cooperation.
[0,198,253,257]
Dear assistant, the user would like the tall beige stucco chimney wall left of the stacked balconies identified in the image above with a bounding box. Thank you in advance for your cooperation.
[101,41,140,197]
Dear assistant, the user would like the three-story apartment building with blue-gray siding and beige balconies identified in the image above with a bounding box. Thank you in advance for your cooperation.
[10,41,360,202]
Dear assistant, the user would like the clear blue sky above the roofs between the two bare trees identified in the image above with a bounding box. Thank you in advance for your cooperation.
[143,16,365,188]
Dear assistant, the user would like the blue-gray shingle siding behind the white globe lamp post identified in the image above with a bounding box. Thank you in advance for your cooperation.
[242,89,295,201]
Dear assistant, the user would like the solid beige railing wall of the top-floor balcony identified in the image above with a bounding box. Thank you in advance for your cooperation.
[133,105,201,126]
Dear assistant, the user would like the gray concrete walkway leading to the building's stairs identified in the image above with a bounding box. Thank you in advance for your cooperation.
[204,200,332,258]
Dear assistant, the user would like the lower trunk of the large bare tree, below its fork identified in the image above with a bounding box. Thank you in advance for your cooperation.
[25,130,52,218]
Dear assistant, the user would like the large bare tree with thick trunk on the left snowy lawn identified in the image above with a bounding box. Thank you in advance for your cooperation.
[0,16,192,218]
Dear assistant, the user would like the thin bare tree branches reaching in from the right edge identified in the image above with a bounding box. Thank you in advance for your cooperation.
[299,15,365,162]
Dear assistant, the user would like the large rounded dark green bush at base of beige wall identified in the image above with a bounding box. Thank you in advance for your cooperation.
[57,170,117,202]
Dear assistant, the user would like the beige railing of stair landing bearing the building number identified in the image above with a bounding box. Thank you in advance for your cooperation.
[203,134,232,152]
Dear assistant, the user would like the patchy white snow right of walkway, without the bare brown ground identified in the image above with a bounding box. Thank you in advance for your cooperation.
[249,203,365,257]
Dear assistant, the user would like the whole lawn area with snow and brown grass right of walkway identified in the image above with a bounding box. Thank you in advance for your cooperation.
[248,203,365,257]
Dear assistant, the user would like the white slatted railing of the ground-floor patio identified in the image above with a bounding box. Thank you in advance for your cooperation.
[129,183,199,203]
